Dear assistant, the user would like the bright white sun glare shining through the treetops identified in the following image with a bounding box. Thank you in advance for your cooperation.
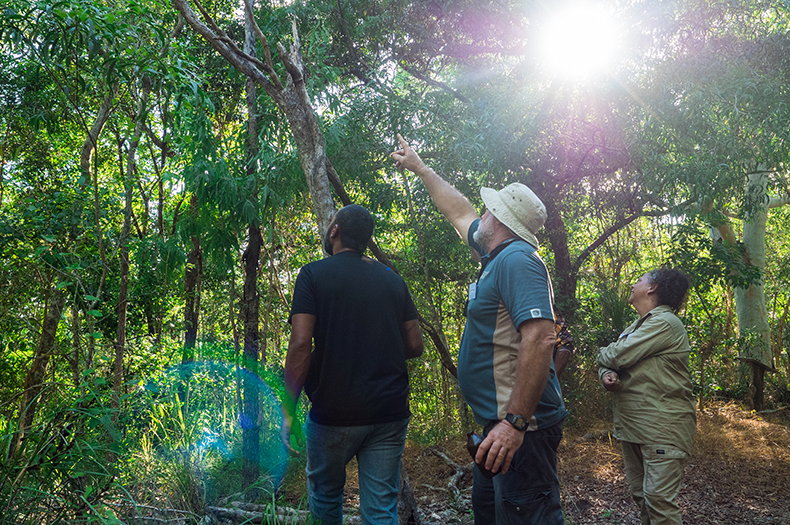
[540,4,618,78]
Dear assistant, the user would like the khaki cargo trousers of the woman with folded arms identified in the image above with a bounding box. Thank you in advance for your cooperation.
[622,441,688,525]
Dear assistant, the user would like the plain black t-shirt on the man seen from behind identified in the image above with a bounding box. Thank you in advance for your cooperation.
[291,251,418,426]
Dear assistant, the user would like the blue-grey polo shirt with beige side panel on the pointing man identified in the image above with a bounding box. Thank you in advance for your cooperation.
[458,220,568,430]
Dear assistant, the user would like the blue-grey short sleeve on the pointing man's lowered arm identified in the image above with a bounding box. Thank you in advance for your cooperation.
[497,250,554,330]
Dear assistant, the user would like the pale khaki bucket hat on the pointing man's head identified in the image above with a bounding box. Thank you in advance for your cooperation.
[480,182,546,248]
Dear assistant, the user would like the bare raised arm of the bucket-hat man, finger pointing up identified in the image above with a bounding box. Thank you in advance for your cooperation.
[390,133,480,244]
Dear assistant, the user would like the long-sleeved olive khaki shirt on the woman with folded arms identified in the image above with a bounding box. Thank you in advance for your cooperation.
[598,306,697,453]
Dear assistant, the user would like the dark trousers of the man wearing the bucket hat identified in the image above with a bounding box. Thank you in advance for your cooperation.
[472,423,565,525]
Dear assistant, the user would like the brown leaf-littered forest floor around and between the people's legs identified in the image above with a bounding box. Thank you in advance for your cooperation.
[332,404,790,525]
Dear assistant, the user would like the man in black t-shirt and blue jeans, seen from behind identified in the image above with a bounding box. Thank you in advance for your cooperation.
[283,204,423,525]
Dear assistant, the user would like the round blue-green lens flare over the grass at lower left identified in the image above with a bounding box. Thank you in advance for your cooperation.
[142,361,288,492]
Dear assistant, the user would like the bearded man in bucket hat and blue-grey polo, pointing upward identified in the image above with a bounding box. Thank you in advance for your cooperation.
[391,135,568,525]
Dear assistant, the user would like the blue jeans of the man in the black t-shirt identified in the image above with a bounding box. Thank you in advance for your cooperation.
[305,418,409,525]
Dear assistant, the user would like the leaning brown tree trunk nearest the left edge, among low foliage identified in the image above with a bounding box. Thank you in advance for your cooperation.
[11,282,66,457]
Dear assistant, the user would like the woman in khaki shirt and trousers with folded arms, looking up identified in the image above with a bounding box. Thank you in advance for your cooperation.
[598,269,696,525]
